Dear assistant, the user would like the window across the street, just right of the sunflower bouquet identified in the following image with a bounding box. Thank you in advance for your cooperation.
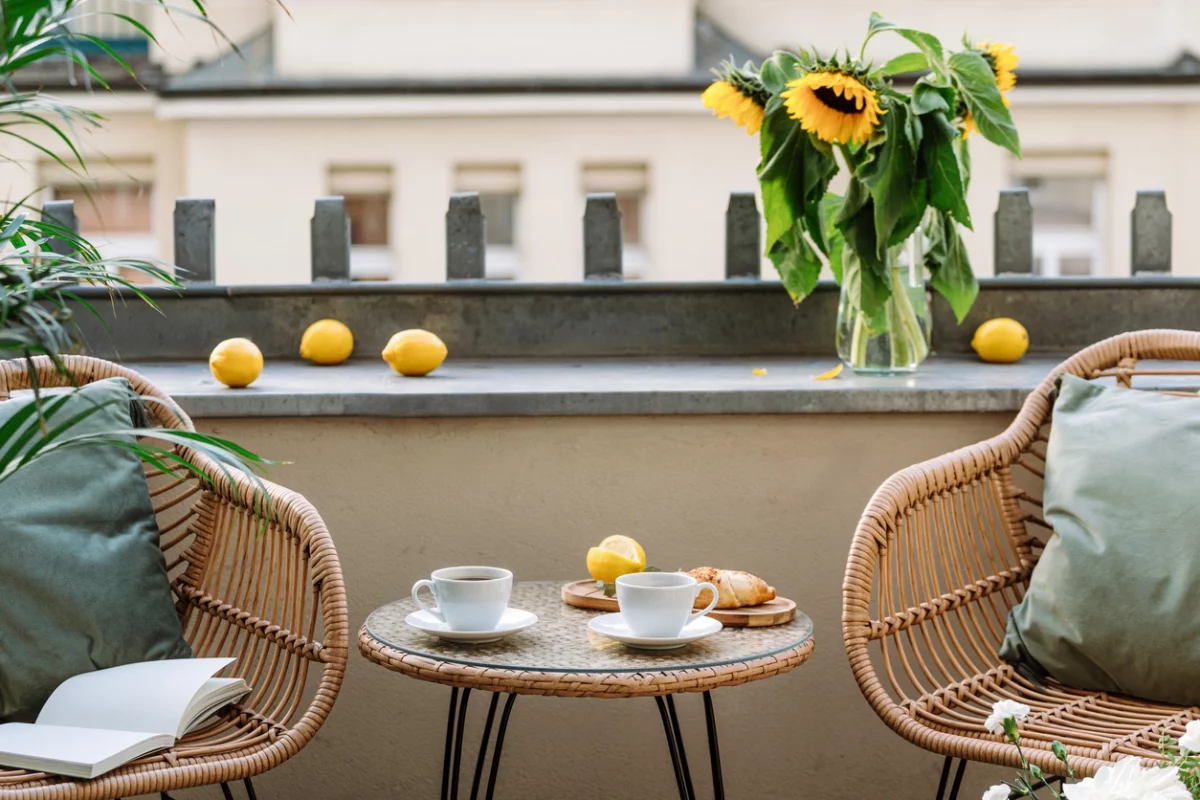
[1013,154,1108,276]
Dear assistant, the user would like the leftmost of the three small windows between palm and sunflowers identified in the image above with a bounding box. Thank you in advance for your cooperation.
[329,167,396,281]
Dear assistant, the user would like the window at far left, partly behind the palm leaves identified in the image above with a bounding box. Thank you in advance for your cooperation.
[38,160,160,282]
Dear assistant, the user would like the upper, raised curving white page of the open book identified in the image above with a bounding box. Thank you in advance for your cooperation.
[37,658,234,736]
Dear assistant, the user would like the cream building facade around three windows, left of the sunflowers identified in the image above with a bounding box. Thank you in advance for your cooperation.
[171,109,757,283]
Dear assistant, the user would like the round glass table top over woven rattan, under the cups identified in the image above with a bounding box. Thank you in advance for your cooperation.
[366,581,812,673]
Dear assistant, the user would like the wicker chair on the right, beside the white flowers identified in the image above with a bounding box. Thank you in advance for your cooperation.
[842,330,1200,794]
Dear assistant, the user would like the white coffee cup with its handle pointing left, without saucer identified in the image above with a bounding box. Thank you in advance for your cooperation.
[413,566,512,631]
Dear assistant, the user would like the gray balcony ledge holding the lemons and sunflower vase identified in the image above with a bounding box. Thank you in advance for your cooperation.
[130,356,1061,419]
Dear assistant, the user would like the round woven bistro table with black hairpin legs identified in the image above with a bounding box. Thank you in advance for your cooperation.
[359,581,815,800]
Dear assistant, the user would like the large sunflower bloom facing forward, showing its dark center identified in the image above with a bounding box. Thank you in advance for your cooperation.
[780,67,887,144]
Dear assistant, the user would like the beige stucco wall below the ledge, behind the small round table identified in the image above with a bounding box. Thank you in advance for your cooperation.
[189,414,1010,800]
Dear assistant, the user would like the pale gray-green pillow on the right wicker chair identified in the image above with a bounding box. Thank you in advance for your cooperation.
[1001,375,1200,705]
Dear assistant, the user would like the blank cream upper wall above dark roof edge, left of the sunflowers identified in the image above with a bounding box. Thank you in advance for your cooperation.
[274,0,695,79]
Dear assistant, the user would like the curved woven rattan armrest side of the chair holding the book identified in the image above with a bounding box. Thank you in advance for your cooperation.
[173,460,349,750]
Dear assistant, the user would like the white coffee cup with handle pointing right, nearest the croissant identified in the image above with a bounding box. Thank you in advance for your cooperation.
[617,572,716,639]
